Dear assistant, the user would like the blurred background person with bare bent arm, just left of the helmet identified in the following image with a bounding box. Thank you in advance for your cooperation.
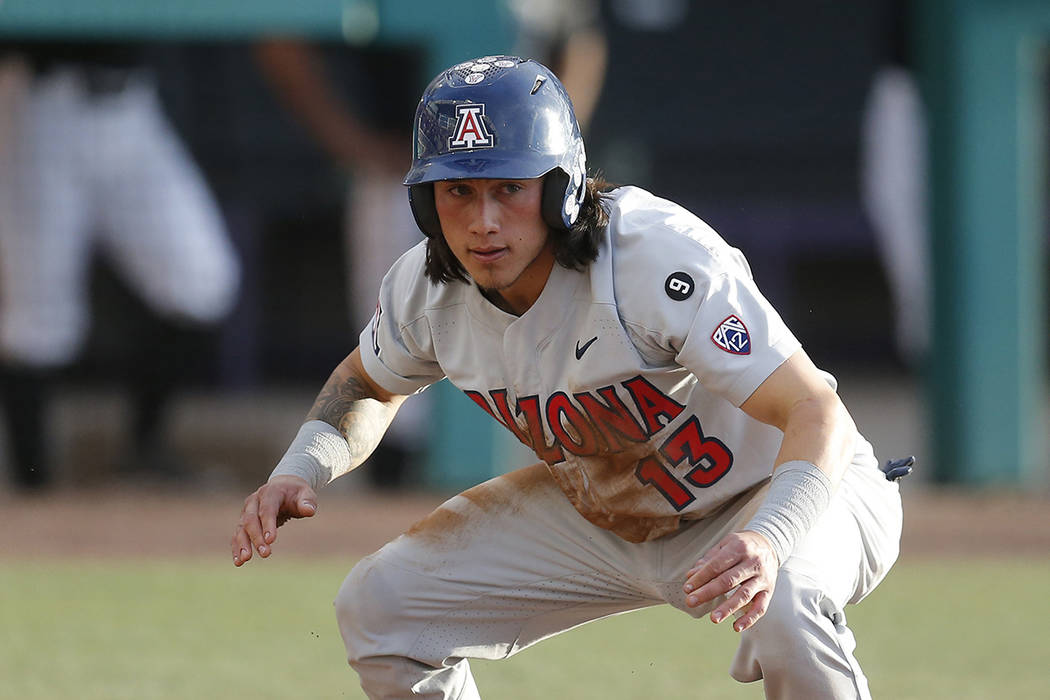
[254,37,433,489]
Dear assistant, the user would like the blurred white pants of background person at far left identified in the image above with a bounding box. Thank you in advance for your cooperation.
[0,62,239,367]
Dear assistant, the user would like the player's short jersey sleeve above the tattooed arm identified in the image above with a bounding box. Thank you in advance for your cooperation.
[359,243,445,395]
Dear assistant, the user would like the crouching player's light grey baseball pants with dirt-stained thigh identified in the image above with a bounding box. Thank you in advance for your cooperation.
[335,440,902,700]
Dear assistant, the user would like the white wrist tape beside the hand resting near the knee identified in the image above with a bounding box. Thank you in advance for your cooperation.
[743,460,833,564]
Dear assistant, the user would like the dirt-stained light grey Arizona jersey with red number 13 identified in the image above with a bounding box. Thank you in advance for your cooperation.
[360,187,834,542]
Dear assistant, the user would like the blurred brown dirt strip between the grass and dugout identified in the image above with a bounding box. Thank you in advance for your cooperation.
[0,487,1050,559]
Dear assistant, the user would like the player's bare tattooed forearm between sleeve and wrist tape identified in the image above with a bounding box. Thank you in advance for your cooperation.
[307,372,394,466]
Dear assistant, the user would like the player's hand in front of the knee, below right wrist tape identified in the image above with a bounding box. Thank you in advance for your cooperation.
[683,530,780,632]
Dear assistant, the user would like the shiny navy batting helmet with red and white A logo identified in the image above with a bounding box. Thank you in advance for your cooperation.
[404,56,587,236]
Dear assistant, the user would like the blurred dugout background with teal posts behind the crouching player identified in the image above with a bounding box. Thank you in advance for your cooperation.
[0,0,1050,497]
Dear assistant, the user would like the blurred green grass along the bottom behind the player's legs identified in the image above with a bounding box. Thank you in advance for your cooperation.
[0,558,1050,700]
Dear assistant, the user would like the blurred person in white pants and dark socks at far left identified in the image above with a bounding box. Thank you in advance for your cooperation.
[0,41,239,490]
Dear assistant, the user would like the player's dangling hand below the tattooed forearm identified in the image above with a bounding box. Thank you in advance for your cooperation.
[230,476,317,567]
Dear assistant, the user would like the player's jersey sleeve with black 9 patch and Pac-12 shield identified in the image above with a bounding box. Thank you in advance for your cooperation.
[612,188,800,406]
